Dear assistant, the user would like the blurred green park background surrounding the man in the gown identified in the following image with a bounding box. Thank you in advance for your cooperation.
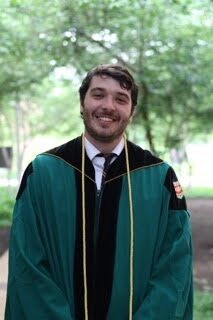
[0,0,213,320]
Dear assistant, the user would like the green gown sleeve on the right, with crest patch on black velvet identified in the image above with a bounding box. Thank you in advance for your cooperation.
[133,168,193,320]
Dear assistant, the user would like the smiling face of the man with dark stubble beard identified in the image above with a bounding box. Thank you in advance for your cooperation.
[81,76,132,143]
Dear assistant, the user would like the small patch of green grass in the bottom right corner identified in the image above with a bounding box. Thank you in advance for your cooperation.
[193,291,213,320]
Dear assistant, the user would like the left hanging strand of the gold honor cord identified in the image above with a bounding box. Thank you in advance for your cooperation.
[81,134,88,320]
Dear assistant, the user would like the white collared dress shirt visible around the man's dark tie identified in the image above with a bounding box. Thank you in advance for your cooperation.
[85,137,124,190]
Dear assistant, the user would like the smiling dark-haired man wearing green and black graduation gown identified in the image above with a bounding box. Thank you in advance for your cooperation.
[5,65,192,320]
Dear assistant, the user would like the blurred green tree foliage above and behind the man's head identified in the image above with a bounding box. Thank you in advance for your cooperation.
[0,0,213,154]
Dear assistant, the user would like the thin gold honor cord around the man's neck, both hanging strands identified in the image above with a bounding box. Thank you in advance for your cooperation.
[81,134,134,320]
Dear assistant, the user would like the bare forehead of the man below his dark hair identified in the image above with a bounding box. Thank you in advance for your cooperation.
[88,75,131,96]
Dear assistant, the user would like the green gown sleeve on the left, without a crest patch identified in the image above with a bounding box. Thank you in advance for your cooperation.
[5,164,74,320]
